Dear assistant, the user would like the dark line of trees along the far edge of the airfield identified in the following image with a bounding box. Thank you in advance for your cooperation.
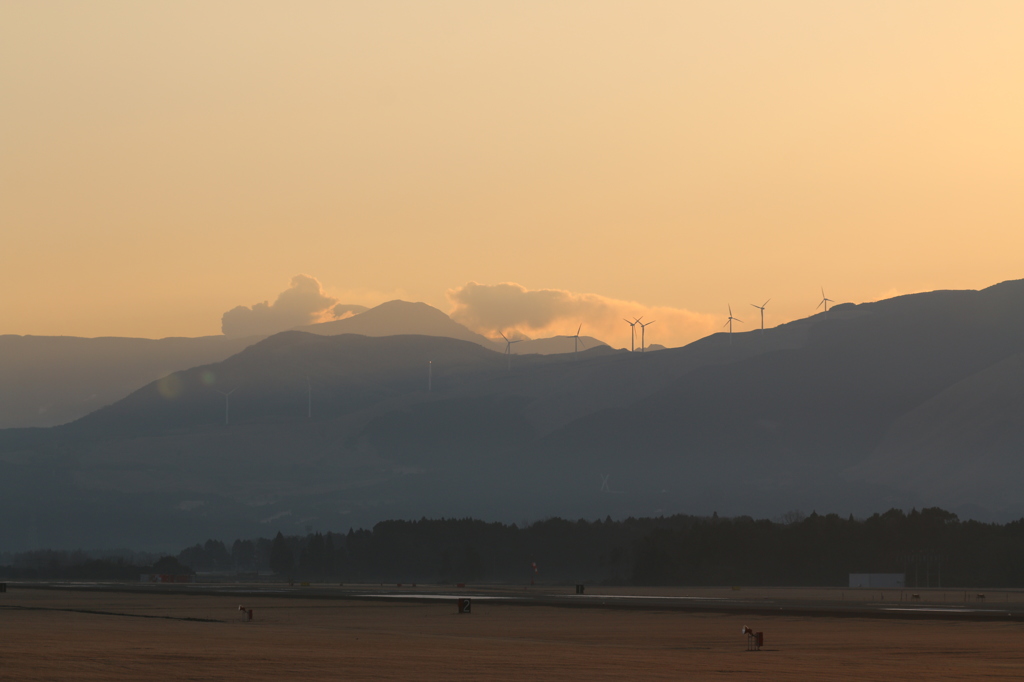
[6,508,1024,587]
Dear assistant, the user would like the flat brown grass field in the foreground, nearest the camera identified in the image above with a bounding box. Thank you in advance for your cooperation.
[0,586,1024,682]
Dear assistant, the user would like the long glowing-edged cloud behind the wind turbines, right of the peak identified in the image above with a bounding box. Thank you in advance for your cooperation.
[447,282,717,348]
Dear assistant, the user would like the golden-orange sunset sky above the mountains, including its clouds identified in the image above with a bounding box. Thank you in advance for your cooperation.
[0,0,1024,346]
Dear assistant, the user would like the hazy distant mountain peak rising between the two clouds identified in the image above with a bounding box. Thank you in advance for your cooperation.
[296,301,497,348]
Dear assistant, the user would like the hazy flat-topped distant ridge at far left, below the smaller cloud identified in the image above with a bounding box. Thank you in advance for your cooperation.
[0,335,258,428]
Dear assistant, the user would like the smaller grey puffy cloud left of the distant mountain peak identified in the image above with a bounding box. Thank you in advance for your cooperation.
[220,274,344,336]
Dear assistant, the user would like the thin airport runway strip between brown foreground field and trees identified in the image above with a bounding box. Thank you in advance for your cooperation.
[8,582,1024,622]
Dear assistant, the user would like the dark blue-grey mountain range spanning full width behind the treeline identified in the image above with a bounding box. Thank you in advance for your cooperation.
[6,282,1024,551]
